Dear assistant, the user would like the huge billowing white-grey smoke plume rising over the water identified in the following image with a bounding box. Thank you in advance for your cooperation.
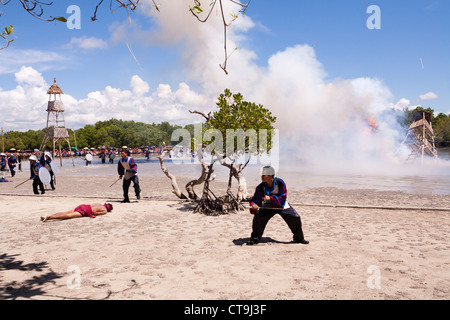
[130,0,446,178]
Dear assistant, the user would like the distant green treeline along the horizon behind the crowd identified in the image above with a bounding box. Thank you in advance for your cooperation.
[4,107,450,151]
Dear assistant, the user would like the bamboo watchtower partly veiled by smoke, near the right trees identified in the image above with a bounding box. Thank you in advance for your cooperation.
[402,110,437,161]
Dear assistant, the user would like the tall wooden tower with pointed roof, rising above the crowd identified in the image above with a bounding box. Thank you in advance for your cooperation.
[40,79,75,166]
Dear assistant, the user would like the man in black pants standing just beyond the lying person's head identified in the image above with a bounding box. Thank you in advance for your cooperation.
[117,149,141,202]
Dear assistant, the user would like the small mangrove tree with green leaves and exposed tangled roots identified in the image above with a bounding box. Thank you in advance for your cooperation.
[160,89,276,215]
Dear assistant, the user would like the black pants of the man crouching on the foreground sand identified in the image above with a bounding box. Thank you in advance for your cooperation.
[251,207,304,241]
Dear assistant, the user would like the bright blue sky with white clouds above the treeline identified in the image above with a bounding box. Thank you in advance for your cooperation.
[0,0,450,130]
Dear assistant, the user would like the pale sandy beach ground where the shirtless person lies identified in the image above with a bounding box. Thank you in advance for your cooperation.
[0,172,450,300]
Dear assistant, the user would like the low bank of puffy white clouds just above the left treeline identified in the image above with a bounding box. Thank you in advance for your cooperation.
[0,67,213,131]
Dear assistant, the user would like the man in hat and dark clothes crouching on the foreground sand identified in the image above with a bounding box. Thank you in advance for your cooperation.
[247,166,309,245]
